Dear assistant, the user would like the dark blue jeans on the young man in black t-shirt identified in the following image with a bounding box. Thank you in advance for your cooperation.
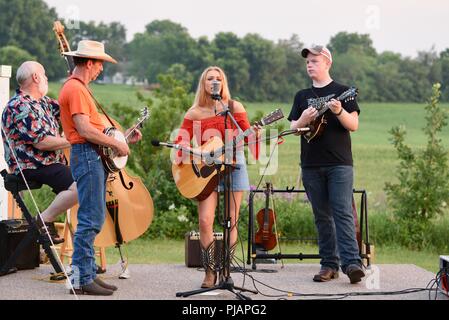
[302,166,361,272]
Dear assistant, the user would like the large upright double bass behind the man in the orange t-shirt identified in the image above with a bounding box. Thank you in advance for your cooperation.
[53,21,154,248]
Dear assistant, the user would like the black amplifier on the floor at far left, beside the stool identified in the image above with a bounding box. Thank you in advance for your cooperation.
[0,219,40,270]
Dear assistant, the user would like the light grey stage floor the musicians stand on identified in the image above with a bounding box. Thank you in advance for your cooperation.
[0,263,448,300]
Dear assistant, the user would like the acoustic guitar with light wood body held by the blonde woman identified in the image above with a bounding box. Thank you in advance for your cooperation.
[172,109,284,201]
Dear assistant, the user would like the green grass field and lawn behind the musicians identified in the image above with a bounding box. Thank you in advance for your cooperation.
[46,83,449,271]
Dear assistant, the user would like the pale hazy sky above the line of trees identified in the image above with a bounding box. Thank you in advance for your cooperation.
[44,0,449,57]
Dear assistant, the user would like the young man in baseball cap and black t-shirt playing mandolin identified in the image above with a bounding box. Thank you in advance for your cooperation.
[288,46,365,283]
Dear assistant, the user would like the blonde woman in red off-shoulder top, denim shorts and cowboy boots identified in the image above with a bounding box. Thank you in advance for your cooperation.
[176,66,259,288]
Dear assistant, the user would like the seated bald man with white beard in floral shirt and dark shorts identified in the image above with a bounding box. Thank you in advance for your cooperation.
[1,61,78,244]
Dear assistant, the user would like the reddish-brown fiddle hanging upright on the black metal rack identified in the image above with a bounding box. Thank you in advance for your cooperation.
[254,182,277,251]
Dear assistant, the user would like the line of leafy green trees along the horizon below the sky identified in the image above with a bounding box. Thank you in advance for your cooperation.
[0,0,449,102]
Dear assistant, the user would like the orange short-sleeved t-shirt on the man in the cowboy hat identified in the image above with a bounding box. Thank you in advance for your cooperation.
[58,76,105,144]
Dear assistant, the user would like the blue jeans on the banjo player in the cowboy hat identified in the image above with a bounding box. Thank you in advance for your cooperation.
[70,143,107,286]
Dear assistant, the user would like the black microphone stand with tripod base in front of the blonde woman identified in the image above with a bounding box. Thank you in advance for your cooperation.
[176,97,257,300]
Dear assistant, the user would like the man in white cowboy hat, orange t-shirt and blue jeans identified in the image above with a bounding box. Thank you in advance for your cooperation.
[59,40,142,295]
